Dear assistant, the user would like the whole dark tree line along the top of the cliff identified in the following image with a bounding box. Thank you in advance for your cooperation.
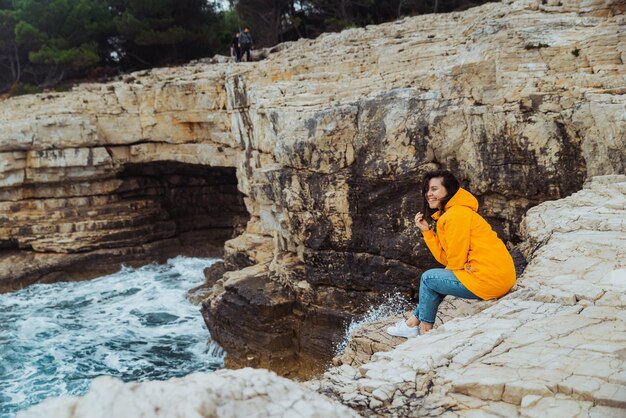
[0,0,488,94]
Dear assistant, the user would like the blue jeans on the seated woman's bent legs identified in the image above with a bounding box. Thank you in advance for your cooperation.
[413,269,480,325]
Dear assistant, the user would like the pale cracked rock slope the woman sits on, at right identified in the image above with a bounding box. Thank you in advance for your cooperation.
[310,175,626,417]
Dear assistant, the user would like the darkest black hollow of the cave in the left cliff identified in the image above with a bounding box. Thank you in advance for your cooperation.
[118,161,250,256]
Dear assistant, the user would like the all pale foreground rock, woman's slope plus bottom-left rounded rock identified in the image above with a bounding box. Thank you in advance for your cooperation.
[18,175,626,418]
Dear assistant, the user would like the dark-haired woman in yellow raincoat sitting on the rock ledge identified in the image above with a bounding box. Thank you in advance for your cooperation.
[387,170,515,338]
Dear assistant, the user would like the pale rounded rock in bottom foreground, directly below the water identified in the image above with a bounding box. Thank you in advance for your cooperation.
[17,369,358,418]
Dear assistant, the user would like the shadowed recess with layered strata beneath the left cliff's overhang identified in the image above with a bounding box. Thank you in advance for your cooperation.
[0,161,250,291]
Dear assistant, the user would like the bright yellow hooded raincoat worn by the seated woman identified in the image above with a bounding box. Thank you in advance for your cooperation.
[422,188,515,299]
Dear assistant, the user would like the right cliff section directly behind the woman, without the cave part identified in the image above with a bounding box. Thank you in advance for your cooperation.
[205,1,626,373]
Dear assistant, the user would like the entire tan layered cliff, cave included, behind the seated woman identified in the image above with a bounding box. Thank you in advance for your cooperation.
[0,0,626,374]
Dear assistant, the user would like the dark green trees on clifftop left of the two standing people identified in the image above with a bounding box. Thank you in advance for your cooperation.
[0,0,224,92]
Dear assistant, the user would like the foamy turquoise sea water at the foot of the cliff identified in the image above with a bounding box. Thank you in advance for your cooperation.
[0,257,224,417]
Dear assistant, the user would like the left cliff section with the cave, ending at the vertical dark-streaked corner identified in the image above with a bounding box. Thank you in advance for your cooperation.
[0,73,250,290]
